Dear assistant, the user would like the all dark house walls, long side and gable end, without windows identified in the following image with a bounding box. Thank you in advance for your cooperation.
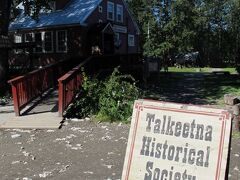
[9,0,140,66]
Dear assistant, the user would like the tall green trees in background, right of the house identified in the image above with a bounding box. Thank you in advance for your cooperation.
[126,0,240,66]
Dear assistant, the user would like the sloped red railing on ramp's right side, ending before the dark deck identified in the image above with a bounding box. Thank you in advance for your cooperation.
[58,57,92,116]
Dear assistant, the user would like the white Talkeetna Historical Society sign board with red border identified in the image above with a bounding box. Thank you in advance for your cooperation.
[122,100,231,180]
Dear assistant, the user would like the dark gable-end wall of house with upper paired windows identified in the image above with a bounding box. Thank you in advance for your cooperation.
[86,0,140,54]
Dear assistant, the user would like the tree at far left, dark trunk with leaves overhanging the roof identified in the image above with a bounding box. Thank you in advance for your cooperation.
[0,0,50,93]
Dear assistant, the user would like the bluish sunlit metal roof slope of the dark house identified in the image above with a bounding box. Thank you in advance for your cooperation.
[9,0,102,31]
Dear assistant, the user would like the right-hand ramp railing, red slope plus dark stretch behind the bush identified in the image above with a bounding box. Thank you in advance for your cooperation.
[58,54,141,116]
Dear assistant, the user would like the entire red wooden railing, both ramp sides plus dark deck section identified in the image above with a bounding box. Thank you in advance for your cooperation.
[8,54,141,116]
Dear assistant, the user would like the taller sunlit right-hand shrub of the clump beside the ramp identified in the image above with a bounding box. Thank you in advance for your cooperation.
[97,69,139,121]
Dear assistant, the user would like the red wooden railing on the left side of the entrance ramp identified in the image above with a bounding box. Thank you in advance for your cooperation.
[8,61,68,116]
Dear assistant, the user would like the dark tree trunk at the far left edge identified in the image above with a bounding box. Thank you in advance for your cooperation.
[0,0,12,94]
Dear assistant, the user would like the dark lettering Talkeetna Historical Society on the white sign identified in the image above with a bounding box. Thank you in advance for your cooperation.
[140,113,213,180]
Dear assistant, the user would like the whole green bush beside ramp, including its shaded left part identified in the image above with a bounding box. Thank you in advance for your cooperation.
[66,68,140,122]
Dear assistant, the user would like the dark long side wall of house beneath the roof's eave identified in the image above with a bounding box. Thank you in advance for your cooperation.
[9,26,87,66]
